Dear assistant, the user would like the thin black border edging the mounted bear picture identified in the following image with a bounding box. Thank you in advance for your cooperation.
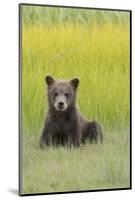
[18,3,132,196]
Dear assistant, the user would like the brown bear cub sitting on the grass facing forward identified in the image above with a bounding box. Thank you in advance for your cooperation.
[40,75,103,148]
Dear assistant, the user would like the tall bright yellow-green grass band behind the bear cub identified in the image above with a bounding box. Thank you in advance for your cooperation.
[22,24,130,134]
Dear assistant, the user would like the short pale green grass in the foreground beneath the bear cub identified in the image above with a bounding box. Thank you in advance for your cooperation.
[22,132,130,194]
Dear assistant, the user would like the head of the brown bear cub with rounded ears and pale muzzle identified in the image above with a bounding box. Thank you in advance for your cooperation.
[45,75,79,112]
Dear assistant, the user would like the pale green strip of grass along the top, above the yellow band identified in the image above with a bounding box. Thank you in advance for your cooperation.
[23,6,129,27]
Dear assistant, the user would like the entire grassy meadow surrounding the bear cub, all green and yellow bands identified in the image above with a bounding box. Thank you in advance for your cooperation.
[22,7,130,193]
